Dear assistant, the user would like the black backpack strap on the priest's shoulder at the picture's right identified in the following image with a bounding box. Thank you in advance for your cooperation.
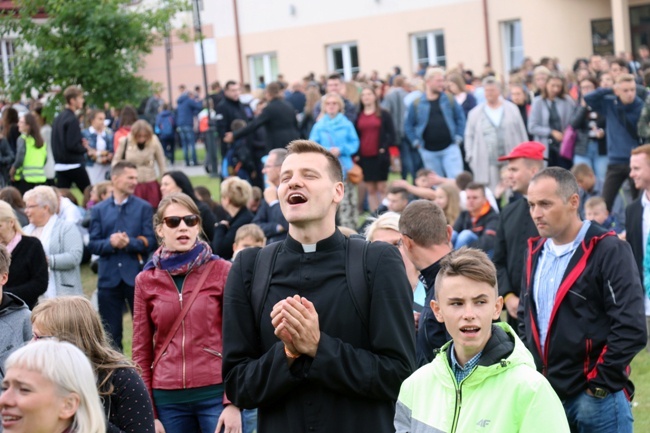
[345,235,371,332]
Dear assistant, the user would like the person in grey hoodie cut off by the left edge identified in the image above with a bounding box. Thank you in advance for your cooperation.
[0,245,32,379]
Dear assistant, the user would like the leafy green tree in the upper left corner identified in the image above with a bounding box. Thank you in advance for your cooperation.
[0,0,188,111]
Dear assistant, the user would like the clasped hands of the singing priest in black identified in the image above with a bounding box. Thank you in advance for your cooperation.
[271,295,320,358]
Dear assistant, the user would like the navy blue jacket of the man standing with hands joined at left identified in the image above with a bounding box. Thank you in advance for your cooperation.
[88,195,156,288]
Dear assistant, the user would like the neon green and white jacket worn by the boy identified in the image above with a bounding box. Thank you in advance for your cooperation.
[395,323,569,433]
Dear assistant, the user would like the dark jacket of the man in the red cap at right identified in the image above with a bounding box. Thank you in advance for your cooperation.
[492,197,538,296]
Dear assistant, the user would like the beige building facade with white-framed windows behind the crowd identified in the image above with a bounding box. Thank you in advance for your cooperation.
[142,0,650,103]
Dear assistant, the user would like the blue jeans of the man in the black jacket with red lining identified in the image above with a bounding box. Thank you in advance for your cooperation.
[562,391,634,433]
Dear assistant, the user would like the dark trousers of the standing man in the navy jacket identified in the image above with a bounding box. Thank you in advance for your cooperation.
[97,281,133,351]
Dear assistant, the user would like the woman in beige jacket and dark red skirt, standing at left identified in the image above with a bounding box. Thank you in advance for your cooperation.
[113,120,166,209]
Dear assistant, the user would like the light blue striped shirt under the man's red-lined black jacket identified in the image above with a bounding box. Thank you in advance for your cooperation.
[533,221,591,353]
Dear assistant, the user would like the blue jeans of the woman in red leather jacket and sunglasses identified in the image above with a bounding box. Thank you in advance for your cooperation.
[156,397,223,433]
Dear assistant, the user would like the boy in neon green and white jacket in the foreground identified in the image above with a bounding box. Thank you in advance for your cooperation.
[395,248,569,433]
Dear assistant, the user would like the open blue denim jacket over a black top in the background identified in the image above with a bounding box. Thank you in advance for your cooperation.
[404,93,465,148]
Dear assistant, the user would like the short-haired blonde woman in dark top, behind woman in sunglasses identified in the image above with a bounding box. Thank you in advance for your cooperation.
[212,177,253,260]
